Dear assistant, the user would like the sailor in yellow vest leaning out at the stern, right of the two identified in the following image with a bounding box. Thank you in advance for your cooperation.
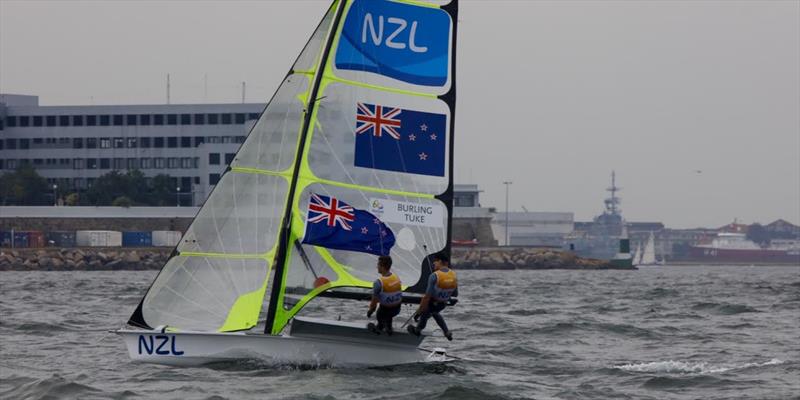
[408,253,458,340]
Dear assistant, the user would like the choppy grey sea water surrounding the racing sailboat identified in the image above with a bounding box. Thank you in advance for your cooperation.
[0,266,800,399]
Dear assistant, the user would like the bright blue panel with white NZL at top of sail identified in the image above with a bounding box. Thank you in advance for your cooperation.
[336,0,451,86]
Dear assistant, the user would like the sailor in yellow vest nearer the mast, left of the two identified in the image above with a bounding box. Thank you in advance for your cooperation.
[367,256,403,335]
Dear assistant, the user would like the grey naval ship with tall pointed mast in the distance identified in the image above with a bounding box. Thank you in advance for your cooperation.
[564,171,630,260]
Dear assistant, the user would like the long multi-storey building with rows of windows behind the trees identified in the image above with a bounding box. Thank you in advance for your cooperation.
[0,94,265,205]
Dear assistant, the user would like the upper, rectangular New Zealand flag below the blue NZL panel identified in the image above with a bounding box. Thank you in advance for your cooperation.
[355,103,447,176]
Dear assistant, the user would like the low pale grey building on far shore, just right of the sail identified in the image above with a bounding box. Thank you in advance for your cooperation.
[492,212,574,247]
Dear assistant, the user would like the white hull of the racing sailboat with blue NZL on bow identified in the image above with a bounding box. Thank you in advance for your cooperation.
[115,319,438,367]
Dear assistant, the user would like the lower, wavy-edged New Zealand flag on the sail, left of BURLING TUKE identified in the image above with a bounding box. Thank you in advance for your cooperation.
[303,193,395,256]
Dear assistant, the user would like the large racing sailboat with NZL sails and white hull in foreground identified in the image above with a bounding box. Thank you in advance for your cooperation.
[115,0,458,366]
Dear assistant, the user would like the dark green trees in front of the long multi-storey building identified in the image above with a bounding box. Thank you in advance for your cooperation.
[0,165,181,207]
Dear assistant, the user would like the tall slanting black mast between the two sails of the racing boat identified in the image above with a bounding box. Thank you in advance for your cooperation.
[264,0,347,334]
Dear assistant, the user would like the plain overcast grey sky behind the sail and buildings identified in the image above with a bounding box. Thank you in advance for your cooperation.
[0,0,800,228]
